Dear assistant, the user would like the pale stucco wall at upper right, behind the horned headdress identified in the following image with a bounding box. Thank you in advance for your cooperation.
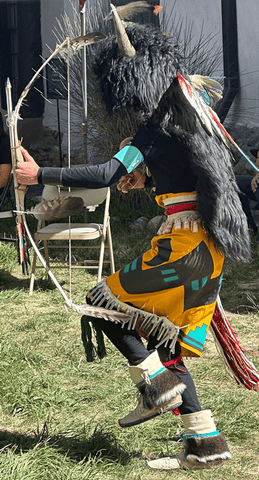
[160,0,259,126]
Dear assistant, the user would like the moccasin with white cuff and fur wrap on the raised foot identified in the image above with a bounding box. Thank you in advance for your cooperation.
[119,351,186,427]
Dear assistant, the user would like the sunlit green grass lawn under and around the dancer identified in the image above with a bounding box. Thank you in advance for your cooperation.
[0,189,259,480]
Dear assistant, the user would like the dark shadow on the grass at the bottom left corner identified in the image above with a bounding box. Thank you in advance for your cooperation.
[0,423,142,465]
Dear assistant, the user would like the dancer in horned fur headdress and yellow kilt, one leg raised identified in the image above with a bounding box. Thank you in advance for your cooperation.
[16,11,250,469]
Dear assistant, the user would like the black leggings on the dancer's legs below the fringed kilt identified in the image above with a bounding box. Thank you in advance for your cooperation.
[90,316,201,415]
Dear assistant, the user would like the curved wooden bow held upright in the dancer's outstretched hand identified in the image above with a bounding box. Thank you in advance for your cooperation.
[6,32,130,323]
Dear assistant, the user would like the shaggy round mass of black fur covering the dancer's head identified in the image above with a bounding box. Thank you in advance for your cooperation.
[94,24,183,115]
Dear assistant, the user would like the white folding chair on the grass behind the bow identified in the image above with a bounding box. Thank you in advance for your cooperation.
[29,186,115,295]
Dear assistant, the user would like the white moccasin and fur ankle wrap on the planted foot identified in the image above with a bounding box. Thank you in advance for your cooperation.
[147,410,231,470]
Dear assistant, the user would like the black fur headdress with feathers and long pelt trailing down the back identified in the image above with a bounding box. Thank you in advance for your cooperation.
[95,19,250,261]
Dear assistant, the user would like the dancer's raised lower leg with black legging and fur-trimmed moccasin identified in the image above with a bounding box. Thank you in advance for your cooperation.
[89,318,186,427]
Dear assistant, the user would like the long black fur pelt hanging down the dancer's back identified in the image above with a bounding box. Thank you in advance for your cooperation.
[148,75,251,262]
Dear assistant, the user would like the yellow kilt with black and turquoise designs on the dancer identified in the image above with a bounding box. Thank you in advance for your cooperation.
[90,195,224,356]
